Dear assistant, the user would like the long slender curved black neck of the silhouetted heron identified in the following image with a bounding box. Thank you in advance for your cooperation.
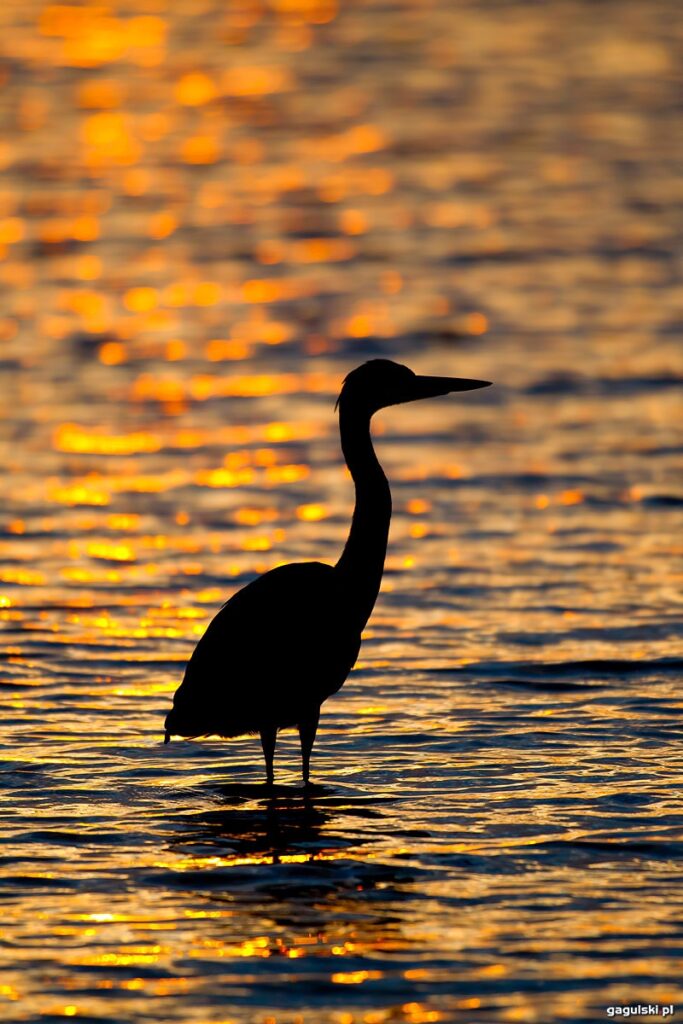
[335,400,391,631]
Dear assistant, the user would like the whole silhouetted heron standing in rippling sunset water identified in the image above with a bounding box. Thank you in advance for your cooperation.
[164,359,490,787]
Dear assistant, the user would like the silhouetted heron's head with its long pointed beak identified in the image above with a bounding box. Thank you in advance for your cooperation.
[337,359,490,416]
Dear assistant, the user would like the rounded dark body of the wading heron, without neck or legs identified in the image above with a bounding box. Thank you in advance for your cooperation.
[167,562,359,735]
